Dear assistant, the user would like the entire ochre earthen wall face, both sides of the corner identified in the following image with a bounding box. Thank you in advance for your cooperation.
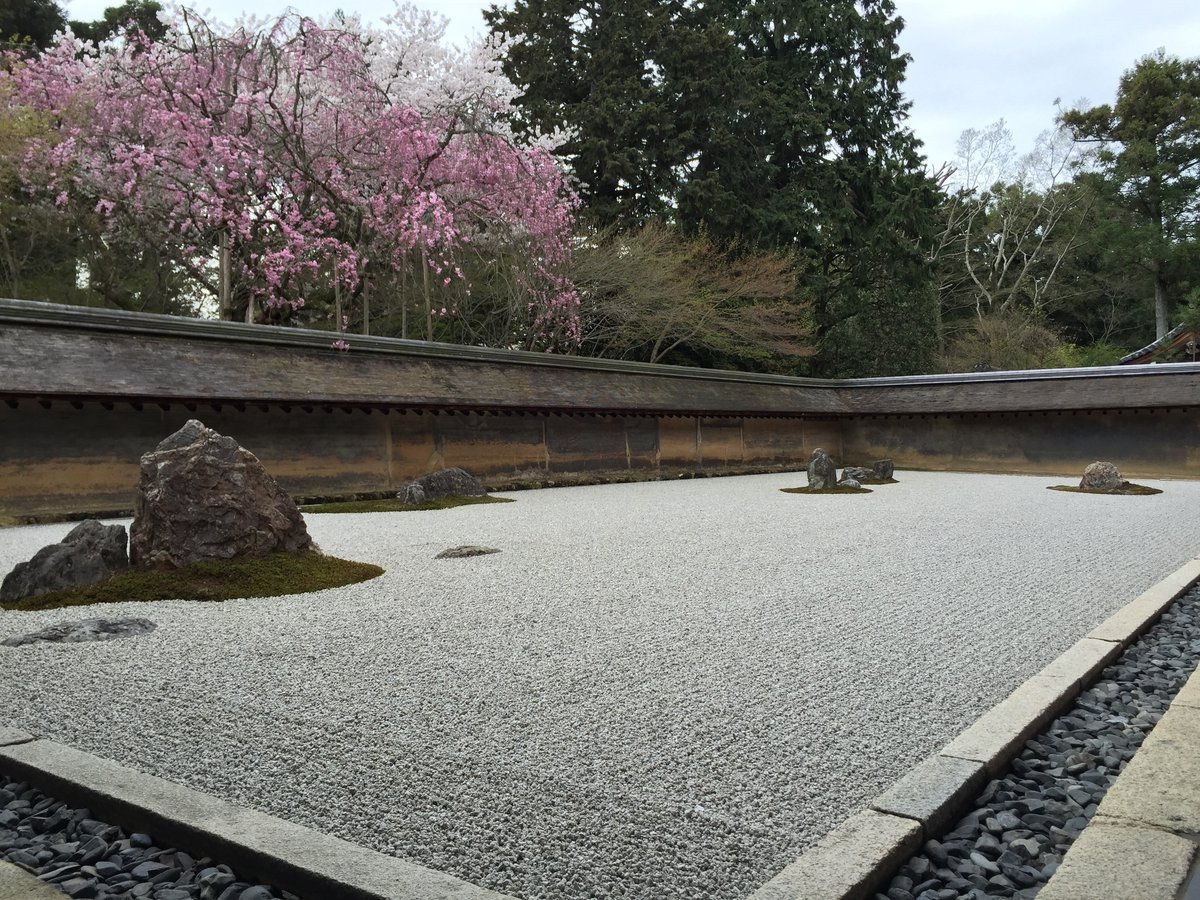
[0,400,1200,520]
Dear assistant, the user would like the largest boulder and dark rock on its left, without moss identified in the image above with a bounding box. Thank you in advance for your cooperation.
[0,419,318,601]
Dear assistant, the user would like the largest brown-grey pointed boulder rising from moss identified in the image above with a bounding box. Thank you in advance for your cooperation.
[130,419,317,566]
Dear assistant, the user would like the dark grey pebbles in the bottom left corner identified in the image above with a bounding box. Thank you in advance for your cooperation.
[0,780,296,900]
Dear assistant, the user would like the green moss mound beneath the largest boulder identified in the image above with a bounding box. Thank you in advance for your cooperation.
[0,553,383,610]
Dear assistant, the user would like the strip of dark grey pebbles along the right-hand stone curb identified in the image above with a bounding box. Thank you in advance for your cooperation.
[876,580,1200,900]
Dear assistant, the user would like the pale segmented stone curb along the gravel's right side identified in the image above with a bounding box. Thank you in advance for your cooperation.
[750,557,1200,900]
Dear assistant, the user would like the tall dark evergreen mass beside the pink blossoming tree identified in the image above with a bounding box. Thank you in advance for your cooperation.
[486,0,940,374]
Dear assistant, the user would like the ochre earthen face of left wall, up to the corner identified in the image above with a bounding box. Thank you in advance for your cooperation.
[0,400,838,520]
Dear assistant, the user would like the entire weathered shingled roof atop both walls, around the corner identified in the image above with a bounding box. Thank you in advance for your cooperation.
[0,300,1200,419]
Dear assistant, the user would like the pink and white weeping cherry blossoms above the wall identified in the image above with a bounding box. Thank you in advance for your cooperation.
[0,11,578,347]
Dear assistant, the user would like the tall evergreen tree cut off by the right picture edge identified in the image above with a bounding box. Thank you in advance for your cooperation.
[1062,50,1200,337]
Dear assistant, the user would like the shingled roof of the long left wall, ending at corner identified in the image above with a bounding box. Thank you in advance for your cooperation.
[0,300,845,416]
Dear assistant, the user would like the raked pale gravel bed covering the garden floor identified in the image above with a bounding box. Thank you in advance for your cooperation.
[0,472,1200,900]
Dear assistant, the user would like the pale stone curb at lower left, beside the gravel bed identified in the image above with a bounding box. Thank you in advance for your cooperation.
[0,727,512,900]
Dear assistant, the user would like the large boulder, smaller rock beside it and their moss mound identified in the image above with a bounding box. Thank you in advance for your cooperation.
[0,419,383,610]
